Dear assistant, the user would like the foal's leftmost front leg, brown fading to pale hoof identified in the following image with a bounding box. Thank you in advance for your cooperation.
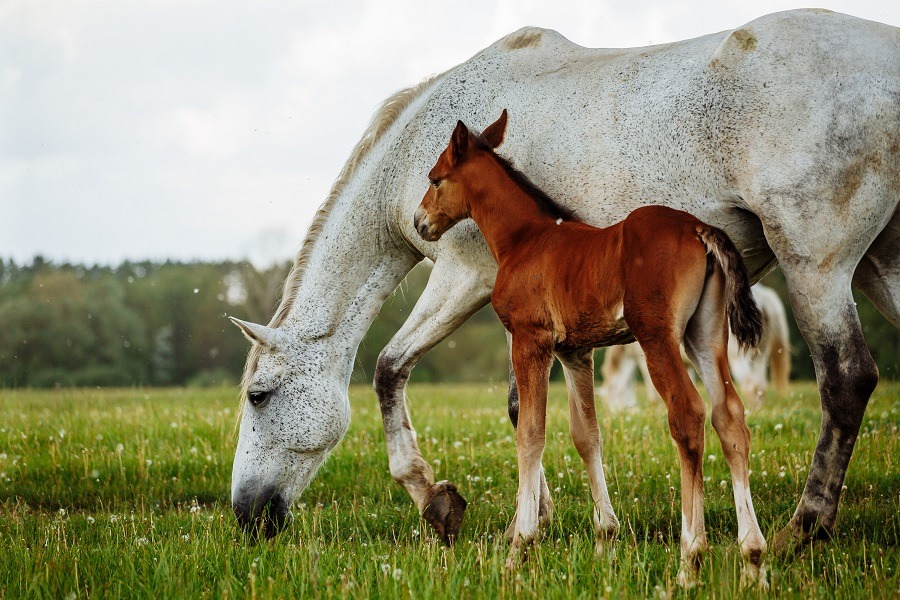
[506,332,553,568]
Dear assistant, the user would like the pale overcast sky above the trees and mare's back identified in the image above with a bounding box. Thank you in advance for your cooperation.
[0,0,900,264]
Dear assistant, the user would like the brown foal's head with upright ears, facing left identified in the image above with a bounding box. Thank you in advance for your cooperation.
[413,109,506,242]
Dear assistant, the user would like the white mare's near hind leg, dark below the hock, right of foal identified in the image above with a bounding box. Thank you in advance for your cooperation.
[748,191,894,551]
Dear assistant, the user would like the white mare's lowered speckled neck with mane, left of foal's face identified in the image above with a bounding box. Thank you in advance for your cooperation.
[268,77,448,380]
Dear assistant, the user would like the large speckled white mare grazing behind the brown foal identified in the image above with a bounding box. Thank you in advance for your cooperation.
[232,10,900,568]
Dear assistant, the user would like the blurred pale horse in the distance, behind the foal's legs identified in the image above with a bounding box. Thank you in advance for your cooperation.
[597,283,791,410]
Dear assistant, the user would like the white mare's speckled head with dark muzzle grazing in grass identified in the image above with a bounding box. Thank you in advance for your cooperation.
[231,318,350,537]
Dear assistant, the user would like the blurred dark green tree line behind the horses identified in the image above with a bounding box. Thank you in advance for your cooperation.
[0,257,900,387]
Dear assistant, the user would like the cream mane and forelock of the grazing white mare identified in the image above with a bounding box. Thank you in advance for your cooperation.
[237,75,440,404]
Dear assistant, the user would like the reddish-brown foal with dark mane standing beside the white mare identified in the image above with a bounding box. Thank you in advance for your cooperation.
[414,111,766,585]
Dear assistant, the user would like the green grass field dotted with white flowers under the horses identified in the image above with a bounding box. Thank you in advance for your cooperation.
[0,382,900,598]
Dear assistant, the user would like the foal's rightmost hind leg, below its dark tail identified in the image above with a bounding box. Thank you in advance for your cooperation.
[684,268,766,585]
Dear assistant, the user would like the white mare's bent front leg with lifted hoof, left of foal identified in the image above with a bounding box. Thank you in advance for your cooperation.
[374,260,490,544]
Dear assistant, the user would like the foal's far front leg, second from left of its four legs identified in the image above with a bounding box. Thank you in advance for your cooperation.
[557,350,619,552]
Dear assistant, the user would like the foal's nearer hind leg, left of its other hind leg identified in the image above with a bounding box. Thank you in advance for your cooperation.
[631,332,707,587]
